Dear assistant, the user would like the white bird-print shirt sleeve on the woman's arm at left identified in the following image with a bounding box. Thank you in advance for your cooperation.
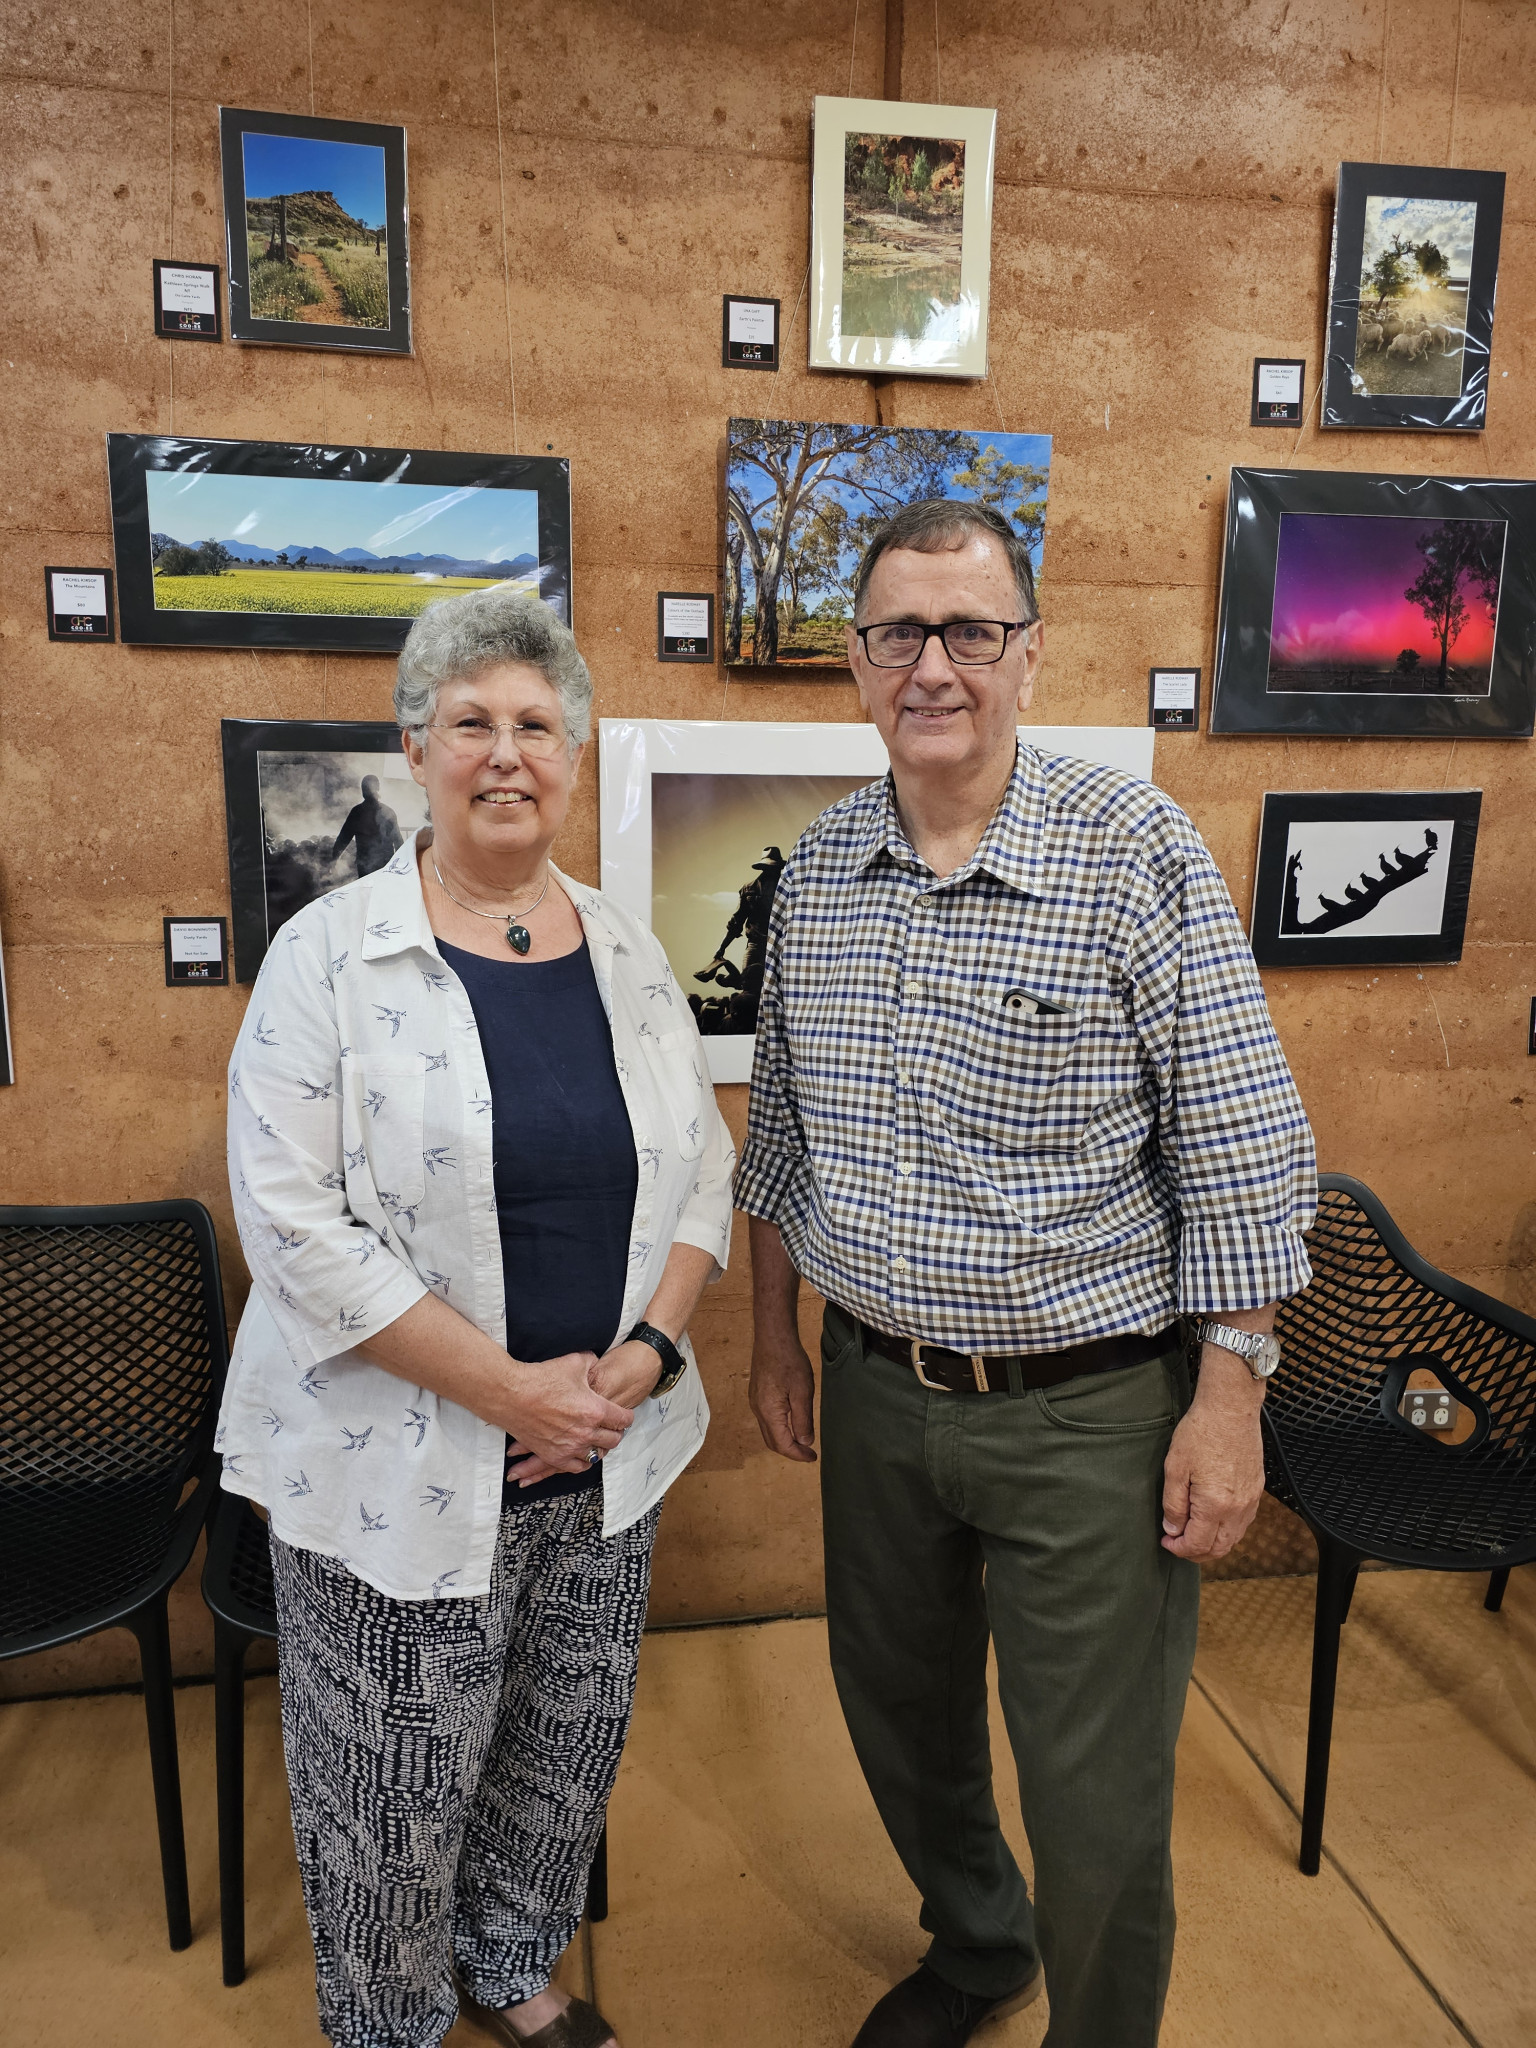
[229,928,428,1364]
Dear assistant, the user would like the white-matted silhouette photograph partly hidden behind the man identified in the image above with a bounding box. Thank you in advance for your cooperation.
[598,719,1153,1081]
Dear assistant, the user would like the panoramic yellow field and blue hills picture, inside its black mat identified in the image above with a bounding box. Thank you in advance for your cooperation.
[145,469,539,618]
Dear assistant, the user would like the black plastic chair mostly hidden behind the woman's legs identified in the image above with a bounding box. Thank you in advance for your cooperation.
[203,1493,608,1985]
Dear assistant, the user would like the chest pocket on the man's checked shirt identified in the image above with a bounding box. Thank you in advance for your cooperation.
[932,997,1094,1155]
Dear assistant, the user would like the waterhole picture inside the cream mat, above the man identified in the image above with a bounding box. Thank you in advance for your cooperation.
[842,135,965,342]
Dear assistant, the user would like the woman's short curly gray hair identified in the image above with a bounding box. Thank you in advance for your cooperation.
[395,584,592,748]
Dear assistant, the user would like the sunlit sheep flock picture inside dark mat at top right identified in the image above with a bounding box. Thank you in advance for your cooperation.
[1354,193,1477,397]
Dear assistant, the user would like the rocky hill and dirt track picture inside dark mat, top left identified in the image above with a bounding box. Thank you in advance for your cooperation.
[242,133,389,328]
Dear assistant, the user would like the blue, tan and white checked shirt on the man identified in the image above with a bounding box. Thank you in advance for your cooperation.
[735,745,1317,1352]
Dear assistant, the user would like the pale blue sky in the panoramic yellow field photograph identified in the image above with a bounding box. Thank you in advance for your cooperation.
[143,469,539,561]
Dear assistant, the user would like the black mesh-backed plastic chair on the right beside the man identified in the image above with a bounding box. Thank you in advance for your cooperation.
[1264,1174,1536,1876]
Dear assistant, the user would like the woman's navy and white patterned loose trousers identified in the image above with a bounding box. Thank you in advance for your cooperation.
[272,1489,659,2048]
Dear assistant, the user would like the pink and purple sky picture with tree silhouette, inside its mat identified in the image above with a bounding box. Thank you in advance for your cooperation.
[1268,512,1505,696]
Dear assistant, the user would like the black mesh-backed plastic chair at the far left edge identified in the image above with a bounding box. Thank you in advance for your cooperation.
[0,1202,227,1948]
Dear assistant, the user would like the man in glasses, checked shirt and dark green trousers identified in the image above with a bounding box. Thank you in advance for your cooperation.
[735,502,1315,2048]
